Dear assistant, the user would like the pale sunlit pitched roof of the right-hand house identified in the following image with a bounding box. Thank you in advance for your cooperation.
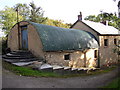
[71,20,120,35]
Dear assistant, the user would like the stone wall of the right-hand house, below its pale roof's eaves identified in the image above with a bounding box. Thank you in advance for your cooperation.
[99,36,120,66]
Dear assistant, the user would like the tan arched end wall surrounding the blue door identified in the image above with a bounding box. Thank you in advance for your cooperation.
[8,22,44,58]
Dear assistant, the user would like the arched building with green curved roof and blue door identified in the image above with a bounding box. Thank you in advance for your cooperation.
[8,21,99,68]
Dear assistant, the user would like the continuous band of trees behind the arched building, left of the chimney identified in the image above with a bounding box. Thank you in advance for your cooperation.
[0,2,71,34]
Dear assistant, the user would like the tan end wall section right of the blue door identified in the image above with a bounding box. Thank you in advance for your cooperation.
[28,25,44,58]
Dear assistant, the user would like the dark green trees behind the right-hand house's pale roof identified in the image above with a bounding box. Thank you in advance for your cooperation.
[85,12,120,30]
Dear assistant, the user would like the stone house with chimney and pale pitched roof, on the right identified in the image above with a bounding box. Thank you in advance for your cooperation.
[71,13,120,66]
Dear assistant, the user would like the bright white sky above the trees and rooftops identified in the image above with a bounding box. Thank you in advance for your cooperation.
[0,0,118,36]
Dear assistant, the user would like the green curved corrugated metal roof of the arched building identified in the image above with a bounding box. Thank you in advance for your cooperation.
[29,22,98,51]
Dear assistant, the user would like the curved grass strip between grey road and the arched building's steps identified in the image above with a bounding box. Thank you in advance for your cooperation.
[2,61,116,78]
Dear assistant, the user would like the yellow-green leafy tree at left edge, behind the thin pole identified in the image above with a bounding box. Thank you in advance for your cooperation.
[0,7,23,34]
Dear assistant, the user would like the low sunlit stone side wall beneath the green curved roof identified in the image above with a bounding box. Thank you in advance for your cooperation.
[46,49,97,68]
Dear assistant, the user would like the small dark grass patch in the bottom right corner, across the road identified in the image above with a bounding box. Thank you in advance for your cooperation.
[102,77,120,90]
